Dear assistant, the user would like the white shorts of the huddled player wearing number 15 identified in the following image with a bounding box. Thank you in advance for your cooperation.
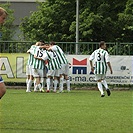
[32,68,46,78]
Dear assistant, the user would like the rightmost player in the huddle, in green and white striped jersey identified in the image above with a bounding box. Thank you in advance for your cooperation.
[49,42,70,92]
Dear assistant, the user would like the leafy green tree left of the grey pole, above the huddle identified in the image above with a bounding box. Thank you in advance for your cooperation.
[20,0,75,41]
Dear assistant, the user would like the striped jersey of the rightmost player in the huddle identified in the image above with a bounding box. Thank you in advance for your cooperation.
[50,45,68,64]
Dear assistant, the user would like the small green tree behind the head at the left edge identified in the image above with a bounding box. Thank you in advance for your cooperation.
[0,3,14,41]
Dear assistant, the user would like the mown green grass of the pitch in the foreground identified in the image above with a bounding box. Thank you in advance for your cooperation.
[0,89,133,133]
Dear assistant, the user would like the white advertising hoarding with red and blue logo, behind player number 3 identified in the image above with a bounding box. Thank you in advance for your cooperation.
[67,55,133,84]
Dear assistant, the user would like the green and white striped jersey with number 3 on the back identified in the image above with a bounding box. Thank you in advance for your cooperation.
[89,48,109,74]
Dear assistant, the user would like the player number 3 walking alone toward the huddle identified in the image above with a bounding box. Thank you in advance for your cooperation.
[89,41,113,97]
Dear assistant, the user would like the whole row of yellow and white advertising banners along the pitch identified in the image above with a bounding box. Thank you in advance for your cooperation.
[0,53,133,84]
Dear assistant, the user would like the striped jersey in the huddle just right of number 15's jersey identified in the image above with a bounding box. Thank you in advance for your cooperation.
[41,50,61,70]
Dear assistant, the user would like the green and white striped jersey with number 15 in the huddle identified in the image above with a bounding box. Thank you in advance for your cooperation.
[30,45,45,69]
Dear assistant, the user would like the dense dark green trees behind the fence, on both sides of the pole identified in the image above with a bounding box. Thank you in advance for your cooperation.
[20,0,132,42]
